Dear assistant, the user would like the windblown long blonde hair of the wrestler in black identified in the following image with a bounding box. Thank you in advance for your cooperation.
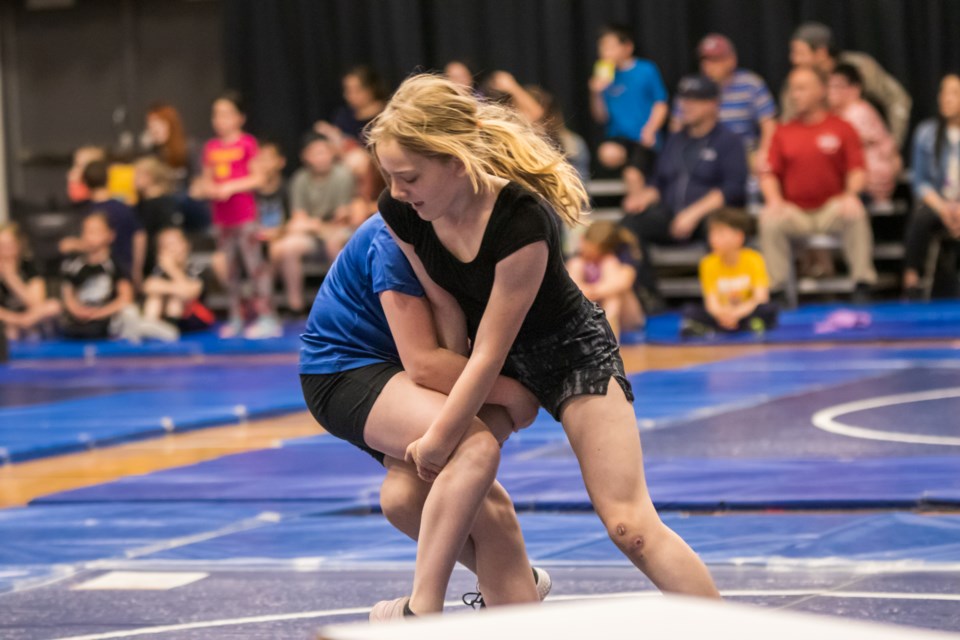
[367,74,589,226]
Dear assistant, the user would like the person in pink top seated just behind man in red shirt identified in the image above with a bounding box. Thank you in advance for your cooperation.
[827,63,903,203]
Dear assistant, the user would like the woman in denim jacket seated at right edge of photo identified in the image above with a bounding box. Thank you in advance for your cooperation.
[903,73,960,299]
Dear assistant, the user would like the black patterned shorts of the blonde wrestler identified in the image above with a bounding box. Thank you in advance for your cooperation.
[503,298,633,421]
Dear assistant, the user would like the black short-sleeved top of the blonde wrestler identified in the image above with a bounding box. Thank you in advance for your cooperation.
[379,182,583,342]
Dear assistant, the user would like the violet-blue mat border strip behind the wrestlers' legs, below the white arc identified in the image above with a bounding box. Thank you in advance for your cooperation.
[33,437,960,511]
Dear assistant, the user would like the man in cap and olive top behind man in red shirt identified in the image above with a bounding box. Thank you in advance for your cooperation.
[780,22,913,149]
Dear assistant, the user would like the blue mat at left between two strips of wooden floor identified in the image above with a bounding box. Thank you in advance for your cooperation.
[0,362,304,461]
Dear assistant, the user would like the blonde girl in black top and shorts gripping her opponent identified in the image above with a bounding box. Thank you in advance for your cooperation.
[368,75,718,610]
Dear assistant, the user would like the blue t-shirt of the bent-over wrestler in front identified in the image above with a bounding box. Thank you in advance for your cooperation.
[300,213,424,374]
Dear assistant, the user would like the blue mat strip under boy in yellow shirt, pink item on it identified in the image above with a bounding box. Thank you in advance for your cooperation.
[623,301,960,345]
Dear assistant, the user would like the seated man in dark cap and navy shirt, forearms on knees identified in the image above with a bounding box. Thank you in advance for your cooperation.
[623,76,747,312]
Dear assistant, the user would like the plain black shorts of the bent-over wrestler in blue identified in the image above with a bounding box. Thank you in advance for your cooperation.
[300,362,403,464]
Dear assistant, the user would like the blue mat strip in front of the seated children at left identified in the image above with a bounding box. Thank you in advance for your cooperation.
[3,321,304,360]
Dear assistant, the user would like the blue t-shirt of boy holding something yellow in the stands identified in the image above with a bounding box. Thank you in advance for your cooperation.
[603,59,667,141]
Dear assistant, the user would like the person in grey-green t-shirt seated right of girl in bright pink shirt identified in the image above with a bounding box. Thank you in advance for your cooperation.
[270,131,356,313]
